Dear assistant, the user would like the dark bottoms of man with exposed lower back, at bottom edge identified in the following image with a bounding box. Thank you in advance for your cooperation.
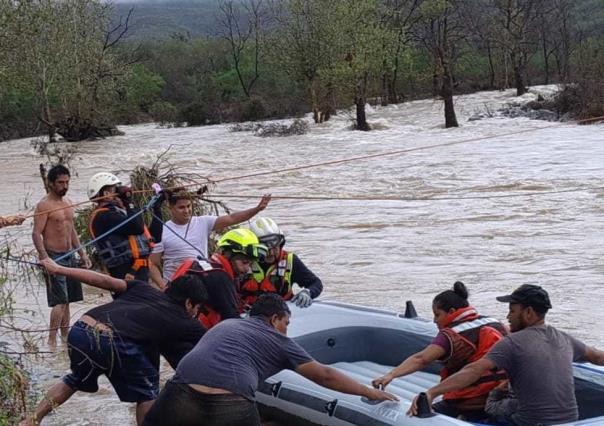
[143,380,260,426]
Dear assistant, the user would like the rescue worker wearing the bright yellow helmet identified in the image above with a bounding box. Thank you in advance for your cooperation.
[168,228,266,329]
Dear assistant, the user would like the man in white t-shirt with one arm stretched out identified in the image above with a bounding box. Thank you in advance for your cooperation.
[149,191,271,288]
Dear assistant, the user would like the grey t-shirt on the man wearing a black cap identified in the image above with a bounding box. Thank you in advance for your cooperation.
[487,325,585,424]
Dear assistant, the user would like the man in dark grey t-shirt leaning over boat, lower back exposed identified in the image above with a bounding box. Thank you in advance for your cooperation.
[144,293,396,426]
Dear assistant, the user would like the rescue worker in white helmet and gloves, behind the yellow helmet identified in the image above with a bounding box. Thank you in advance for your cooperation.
[239,217,323,309]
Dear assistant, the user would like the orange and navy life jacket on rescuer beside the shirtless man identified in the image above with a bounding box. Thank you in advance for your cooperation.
[88,205,154,275]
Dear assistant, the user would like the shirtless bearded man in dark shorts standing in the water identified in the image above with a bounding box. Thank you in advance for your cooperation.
[32,165,92,346]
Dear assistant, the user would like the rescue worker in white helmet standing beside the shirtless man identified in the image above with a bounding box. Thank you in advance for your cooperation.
[88,172,161,282]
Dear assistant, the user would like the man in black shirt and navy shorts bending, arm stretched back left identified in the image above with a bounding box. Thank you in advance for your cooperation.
[22,258,207,425]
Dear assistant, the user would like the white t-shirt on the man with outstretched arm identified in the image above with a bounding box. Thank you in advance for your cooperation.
[153,216,217,279]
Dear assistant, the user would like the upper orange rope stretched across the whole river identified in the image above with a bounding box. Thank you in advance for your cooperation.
[8,116,604,218]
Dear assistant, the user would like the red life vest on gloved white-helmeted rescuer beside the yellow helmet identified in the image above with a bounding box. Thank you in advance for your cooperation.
[239,250,294,307]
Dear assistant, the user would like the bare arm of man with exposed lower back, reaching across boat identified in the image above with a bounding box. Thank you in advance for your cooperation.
[296,361,398,401]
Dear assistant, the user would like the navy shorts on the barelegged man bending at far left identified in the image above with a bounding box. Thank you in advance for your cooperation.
[63,321,159,402]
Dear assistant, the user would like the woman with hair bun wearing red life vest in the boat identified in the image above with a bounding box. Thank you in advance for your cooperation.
[372,281,507,421]
